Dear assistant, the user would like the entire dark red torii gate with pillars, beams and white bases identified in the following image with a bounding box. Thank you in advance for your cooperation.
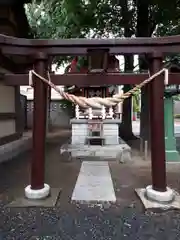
[0,35,180,201]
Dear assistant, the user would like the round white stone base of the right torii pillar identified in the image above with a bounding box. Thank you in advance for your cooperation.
[145,185,175,203]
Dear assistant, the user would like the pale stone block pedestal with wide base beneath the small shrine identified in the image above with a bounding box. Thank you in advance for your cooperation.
[60,118,131,162]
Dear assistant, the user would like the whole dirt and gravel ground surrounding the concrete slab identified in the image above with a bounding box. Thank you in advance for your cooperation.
[0,134,180,240]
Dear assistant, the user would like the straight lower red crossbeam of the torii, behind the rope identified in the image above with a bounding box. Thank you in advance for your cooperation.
[3,73,180,87]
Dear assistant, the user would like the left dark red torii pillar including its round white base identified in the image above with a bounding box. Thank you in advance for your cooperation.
[25,52,50,199]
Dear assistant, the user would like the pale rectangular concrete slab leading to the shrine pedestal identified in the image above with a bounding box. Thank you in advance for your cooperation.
[71,161,116,203]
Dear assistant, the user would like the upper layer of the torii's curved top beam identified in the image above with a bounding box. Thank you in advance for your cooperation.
[0,34,180,47]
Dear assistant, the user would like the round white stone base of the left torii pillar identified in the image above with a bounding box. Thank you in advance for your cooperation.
[25,183,50,200]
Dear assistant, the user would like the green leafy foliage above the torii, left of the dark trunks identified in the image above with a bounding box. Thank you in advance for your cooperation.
[27,0,134,38]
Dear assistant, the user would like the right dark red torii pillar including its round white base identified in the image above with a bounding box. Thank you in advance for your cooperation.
[146,53,174,203]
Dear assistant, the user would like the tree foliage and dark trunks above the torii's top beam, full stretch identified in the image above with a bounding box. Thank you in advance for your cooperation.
[26,0,180,67]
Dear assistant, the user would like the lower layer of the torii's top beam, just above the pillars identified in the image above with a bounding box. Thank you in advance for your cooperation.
[0,43,180,56]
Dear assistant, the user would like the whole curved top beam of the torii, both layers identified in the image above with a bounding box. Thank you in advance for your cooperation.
[0,35,180,56]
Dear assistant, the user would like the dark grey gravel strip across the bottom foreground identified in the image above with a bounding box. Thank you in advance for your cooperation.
[0,206,180,240]
